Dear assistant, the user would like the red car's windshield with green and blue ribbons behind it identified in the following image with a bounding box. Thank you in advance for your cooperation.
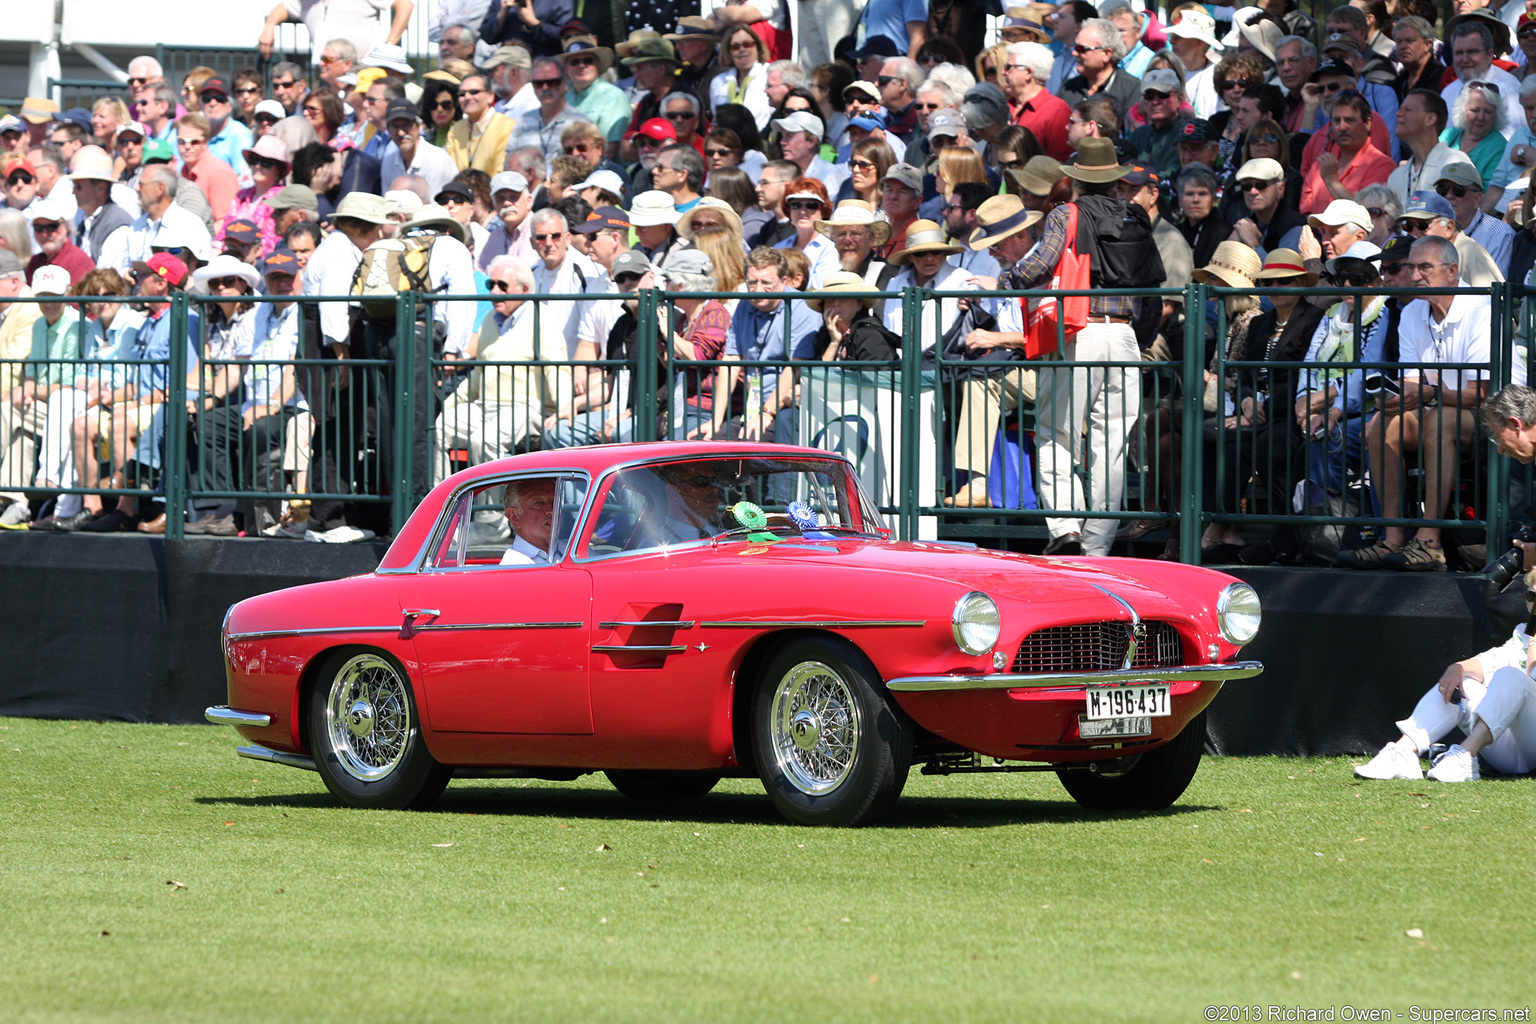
[585,457,883,557]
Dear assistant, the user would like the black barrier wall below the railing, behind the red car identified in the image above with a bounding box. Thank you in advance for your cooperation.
[0,533,1524,755]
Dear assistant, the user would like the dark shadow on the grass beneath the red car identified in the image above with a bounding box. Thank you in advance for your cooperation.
[195,780,1224,831]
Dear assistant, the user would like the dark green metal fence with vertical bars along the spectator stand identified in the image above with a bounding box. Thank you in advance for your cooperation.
[0,284,1536,562]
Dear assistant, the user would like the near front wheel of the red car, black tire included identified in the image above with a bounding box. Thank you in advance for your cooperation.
[753,637,912,826]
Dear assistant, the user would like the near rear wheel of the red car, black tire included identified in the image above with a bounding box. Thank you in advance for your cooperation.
[309,648,453,811]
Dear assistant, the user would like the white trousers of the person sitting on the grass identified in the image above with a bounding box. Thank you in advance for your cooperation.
[1398,668,1536,775]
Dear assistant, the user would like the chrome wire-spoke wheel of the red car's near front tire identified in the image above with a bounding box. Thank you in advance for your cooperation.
[768,662,863,797]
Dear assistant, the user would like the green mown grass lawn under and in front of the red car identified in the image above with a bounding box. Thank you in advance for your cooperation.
[0,718,1536,1024]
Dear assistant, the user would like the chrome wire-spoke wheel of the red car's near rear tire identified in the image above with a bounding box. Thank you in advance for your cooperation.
[324,654,415,781]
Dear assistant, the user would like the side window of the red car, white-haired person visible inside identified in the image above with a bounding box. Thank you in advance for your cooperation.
[432,476,587,570]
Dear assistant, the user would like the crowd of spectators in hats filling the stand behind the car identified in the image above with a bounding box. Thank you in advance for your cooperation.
[0,0,1536,561]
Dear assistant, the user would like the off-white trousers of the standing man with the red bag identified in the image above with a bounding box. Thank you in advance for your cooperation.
[1035,324,1141,554]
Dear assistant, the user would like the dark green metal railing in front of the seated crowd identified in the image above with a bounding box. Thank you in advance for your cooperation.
[0,284,1536,562]
